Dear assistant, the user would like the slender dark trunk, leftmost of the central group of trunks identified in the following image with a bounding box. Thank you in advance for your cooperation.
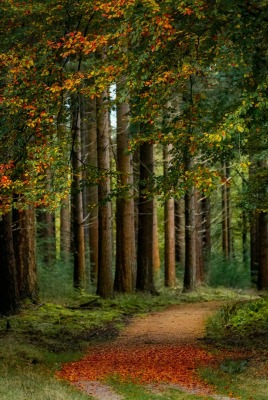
[71,99,86,289]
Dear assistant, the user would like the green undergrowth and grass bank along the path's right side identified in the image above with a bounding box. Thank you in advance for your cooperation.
[200,297,268,400]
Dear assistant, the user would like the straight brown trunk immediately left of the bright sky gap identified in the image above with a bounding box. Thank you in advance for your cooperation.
[97,91,113,298]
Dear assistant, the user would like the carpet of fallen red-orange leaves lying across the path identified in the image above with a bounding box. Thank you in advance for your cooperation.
[57,345,218,389]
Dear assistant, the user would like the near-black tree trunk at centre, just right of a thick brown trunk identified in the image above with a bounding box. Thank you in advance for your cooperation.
[136,142,156,294]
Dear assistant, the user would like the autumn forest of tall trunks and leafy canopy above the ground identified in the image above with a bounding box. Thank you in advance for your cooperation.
[0,0,268,315]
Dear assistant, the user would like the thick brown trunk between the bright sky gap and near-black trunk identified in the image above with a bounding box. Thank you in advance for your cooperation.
[114,87,136,292]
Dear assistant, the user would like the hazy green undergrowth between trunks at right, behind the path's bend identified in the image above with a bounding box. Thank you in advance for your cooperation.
[207,255,250,289]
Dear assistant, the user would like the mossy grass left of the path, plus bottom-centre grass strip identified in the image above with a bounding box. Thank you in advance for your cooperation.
[0,288,264,400]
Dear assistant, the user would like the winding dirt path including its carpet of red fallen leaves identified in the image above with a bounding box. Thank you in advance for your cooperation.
[58,301,241,400]
